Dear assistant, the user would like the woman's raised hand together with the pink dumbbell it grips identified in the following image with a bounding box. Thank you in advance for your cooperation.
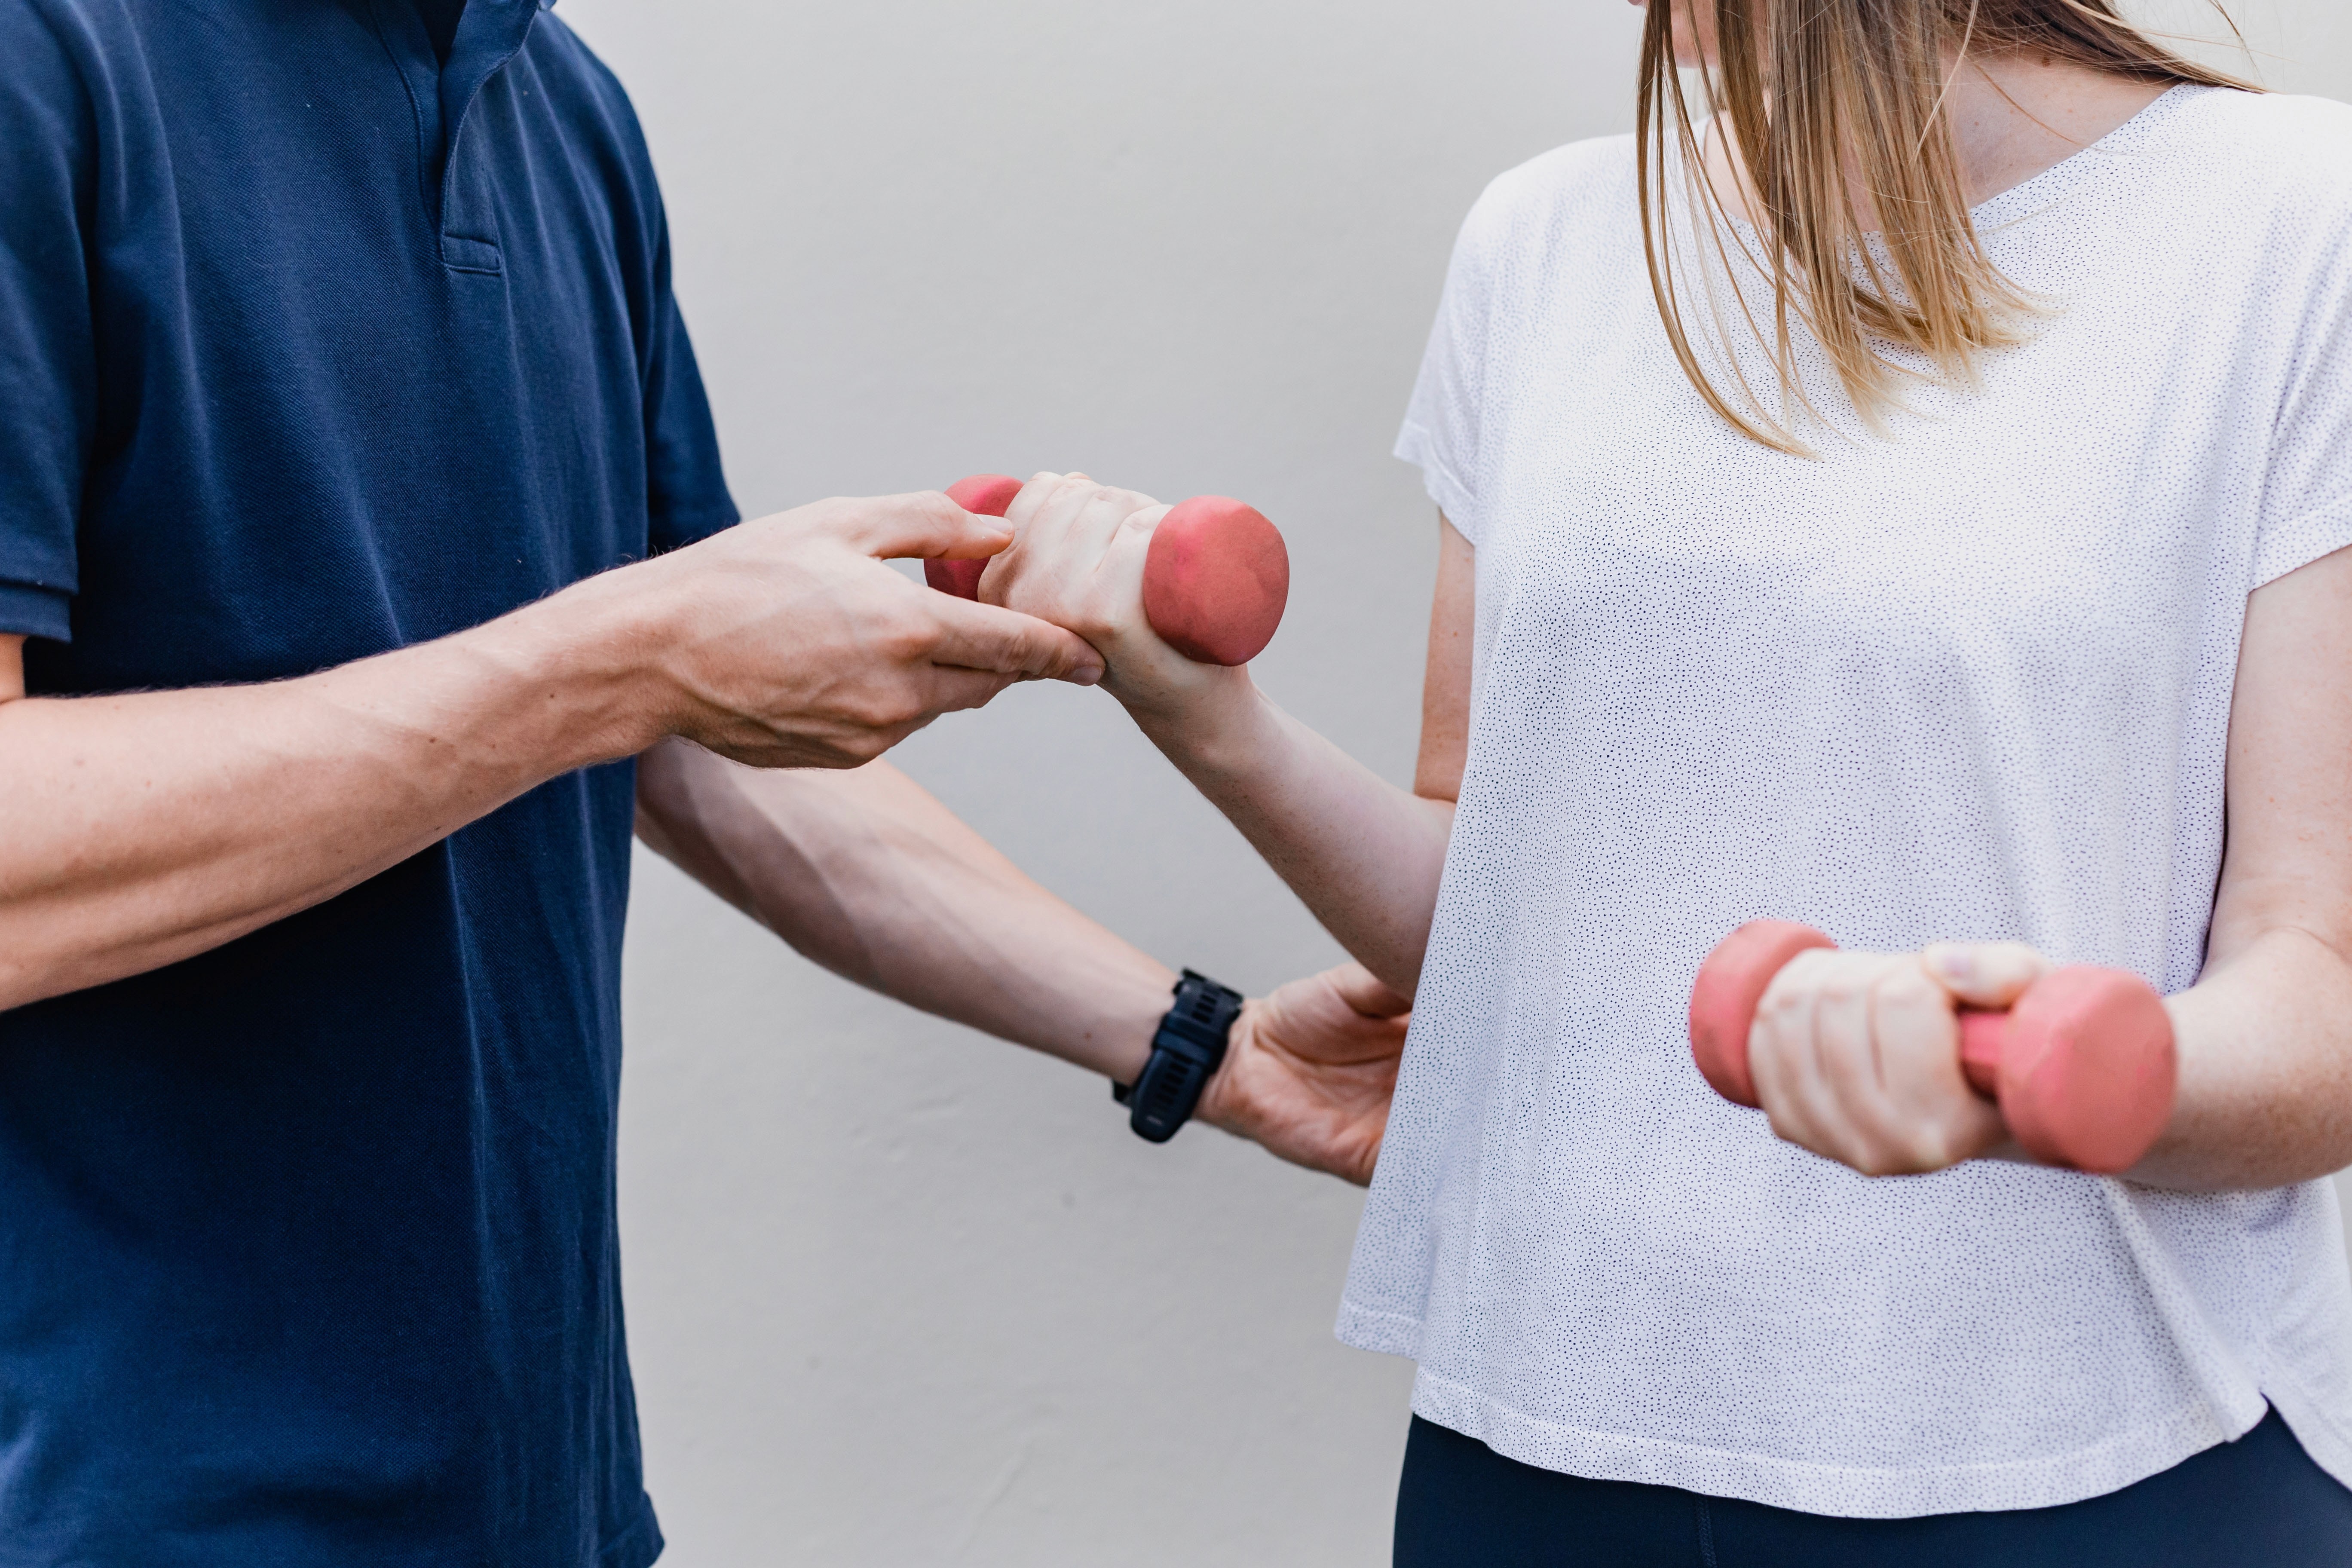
[929,472,1289,717]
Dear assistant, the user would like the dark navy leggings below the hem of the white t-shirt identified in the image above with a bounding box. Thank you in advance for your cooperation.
[1397,1413,2352,1568]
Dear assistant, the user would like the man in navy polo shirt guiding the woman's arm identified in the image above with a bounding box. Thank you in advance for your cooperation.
[0,0,1402,1568]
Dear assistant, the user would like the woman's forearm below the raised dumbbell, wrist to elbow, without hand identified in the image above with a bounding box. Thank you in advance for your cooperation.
[1136,670,1454,997]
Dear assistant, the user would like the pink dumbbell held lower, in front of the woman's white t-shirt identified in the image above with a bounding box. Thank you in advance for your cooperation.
[1691,919,2178,1176]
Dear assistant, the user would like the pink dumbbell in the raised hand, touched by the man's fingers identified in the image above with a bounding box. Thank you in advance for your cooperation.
[922,475,1291,665]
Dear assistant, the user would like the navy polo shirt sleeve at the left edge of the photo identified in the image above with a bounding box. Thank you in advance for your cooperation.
[0,2,96,642]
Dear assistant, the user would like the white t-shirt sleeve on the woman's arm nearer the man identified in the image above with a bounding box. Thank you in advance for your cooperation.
[1397,176,1510,545]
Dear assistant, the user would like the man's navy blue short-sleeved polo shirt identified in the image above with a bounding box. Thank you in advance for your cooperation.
[0,0,736,1568]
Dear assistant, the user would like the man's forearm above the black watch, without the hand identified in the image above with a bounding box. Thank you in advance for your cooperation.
[637,741,1176,1084]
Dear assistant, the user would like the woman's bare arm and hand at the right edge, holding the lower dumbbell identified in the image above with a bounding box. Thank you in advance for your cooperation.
[1750,550,2352,1192]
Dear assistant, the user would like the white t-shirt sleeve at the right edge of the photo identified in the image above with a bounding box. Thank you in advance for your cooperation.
[2253,217,2352,588]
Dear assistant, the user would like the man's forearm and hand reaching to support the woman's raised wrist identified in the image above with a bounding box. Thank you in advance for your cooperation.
[0,494,1101,1011]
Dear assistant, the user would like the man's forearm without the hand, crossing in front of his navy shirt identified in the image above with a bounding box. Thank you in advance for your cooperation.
[0,600,652,1011]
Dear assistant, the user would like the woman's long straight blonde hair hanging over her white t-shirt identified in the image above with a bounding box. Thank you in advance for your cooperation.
[1635,0,2244,454]
